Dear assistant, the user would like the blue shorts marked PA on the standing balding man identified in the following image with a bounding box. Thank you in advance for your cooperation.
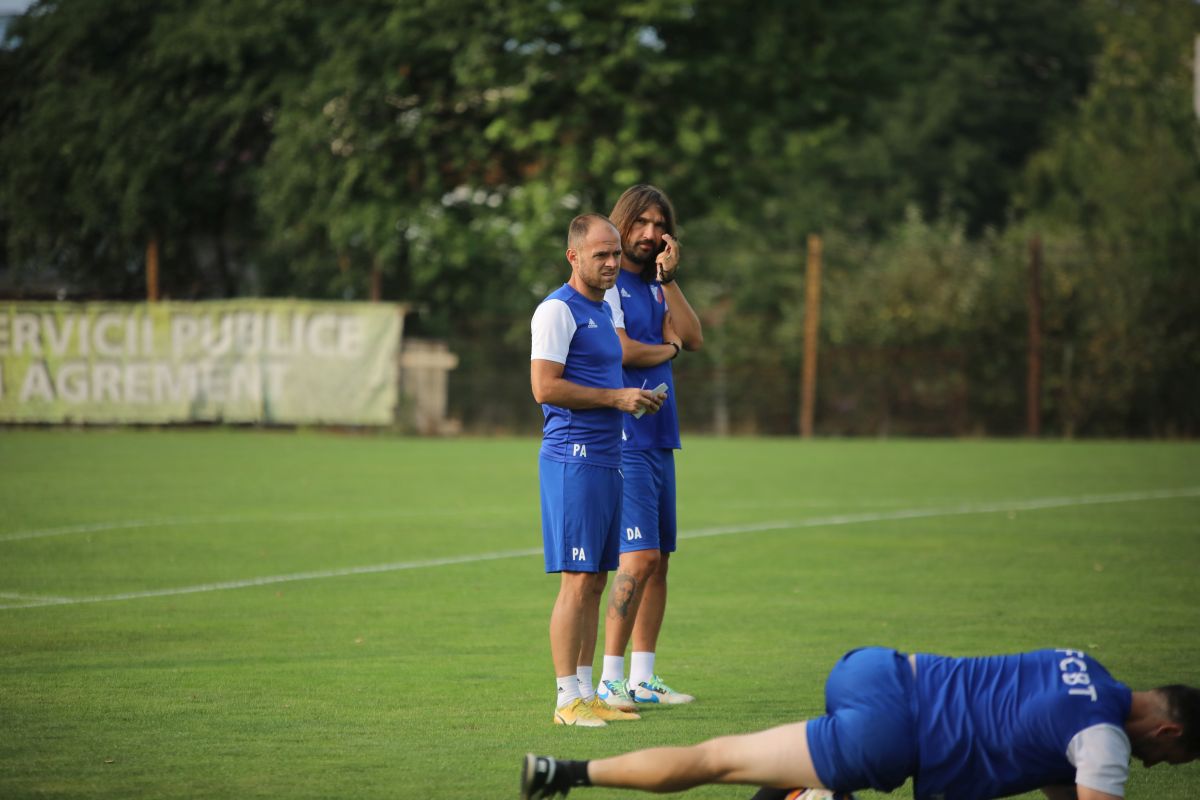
[538,456,623,572]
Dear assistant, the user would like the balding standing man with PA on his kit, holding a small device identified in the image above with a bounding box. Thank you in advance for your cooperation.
[529,213,662,727]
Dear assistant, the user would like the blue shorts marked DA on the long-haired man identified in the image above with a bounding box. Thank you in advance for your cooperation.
[620,450,676,553]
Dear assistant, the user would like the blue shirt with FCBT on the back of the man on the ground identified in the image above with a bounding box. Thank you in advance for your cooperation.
[914,650,1133,800]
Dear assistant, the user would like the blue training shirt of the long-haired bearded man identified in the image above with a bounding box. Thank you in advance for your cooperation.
[605,270,680,450]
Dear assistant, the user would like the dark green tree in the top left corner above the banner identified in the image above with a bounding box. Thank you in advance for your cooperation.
[0,0,307,296]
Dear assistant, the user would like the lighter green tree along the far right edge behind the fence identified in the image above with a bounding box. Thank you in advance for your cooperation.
[1019,2,1200,435]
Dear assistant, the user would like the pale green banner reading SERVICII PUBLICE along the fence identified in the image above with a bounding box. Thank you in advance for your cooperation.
[0,300,403,425]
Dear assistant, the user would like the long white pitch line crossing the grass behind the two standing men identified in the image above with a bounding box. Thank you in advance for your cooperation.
[0,487,1200,610]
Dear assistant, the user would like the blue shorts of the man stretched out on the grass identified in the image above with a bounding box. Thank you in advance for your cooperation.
[808,648,917,792]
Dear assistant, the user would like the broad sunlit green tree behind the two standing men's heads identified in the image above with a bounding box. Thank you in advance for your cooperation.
[255,0,936,328]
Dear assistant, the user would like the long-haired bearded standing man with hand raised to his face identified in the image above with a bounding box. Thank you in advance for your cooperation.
[599,184,703,710]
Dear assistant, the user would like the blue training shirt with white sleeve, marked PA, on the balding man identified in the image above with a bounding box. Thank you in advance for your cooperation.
[530,283,628,467]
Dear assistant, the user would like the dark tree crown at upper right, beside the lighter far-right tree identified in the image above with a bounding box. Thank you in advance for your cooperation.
[775,0,1096,235]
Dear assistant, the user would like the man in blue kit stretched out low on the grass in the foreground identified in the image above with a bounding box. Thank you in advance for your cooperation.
[521,648,1200,800]
